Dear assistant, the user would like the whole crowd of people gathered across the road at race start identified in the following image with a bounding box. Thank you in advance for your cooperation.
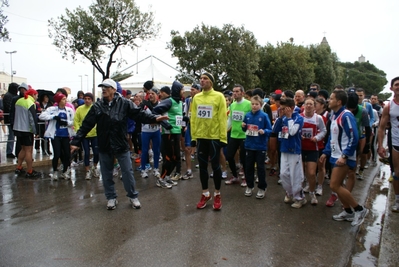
[1,72,399,229]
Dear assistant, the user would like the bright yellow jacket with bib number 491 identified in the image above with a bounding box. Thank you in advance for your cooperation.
[190,88,227,144]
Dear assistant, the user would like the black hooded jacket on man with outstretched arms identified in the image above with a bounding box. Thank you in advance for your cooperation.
[71,93,157,154]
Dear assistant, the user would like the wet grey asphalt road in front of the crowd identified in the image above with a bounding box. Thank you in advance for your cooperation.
[0,161,377,266]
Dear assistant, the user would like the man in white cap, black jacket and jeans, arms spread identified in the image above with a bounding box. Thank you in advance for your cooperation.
[71,79,168,210]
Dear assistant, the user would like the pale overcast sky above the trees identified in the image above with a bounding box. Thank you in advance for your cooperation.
[0,0,399,98]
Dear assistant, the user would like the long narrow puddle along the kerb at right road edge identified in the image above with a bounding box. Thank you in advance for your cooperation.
[349,165,390,266]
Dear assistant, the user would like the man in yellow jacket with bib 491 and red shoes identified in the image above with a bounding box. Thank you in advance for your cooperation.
[190,72,227,210]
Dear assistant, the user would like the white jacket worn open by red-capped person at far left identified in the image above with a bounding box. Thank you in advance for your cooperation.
[39,106,75,139]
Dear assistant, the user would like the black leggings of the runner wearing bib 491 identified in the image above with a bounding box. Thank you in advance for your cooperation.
[197,139,222,190]
